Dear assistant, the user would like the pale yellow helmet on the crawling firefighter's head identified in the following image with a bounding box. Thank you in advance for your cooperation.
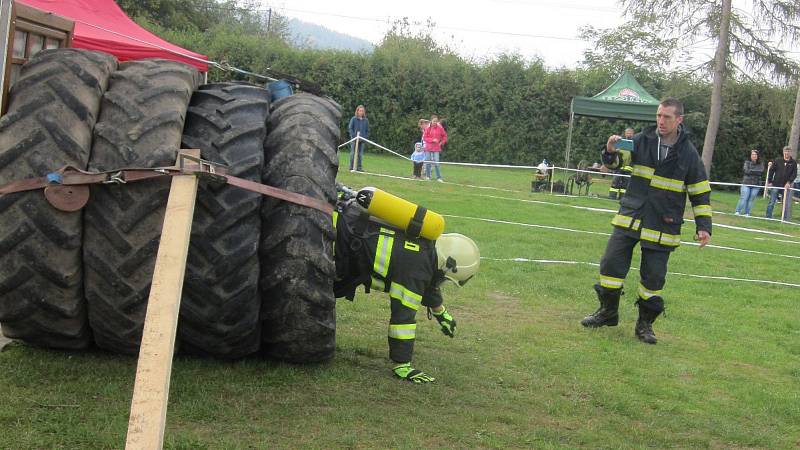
[436,233,481,286]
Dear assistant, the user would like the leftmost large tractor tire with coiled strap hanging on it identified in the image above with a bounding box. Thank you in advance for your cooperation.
[0,49,117,349]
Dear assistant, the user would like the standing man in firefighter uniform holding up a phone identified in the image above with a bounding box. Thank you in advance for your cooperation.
[581,98,711,344]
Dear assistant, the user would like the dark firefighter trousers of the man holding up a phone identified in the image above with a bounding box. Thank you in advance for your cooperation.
[600,227,671,301]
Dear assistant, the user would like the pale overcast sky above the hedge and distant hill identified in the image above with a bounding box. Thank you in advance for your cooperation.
[263,0,622,67]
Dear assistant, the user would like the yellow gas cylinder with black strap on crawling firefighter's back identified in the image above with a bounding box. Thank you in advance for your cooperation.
[356,187,444,241]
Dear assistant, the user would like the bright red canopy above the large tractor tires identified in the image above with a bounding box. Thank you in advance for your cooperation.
[17,0,208,72]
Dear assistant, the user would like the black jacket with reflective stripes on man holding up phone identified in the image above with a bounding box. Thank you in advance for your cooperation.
[602,126,711,251]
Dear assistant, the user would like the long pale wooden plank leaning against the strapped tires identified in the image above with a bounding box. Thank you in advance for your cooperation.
[125,150,200,450]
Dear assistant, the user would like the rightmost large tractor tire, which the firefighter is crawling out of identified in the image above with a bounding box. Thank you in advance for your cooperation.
[259,94,341,363]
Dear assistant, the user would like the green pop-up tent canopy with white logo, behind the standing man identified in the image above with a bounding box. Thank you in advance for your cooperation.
[565,72,659,165]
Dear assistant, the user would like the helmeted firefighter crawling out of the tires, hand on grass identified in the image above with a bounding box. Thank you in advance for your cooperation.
[334,199,480,383]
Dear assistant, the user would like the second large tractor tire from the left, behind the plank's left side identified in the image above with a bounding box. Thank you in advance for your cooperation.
[83,59,199,354]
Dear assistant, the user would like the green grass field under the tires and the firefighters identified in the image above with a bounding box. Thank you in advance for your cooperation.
[0,154,800,449]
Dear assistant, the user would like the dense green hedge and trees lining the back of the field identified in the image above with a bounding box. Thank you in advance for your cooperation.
[118,0,796,182]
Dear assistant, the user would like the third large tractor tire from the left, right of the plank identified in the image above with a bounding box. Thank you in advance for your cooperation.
[178,83,270,358]
